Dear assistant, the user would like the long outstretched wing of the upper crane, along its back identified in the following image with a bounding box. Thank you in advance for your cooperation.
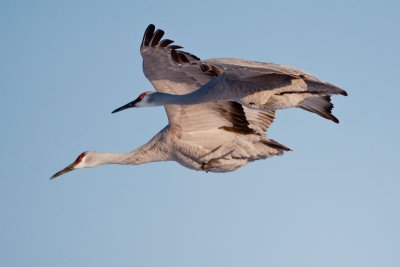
[197,58,347,98]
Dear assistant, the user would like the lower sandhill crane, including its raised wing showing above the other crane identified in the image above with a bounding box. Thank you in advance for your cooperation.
[50,25,290,179]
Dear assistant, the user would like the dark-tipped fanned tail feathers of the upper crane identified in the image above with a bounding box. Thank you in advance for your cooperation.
[298,95,339,123]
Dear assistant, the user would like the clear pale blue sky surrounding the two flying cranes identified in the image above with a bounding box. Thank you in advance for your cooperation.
[0,0,400,267]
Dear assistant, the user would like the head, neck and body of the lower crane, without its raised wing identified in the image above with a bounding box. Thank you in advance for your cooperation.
[51,115,290,179]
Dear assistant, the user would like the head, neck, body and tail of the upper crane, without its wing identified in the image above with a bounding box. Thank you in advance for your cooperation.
[119,70,347,123]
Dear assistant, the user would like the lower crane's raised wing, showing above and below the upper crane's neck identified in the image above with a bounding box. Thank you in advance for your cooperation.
[140,24,275,133]
